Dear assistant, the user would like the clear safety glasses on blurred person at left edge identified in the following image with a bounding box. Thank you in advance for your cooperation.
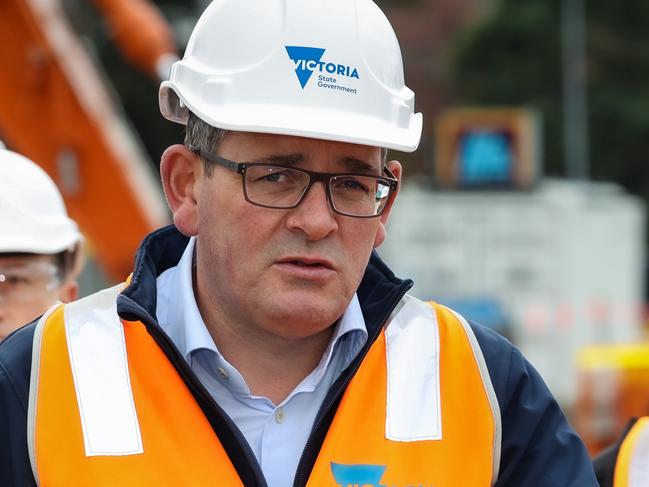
[0,261,61,302]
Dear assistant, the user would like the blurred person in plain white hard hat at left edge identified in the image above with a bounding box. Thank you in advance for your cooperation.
[0,148,82,341]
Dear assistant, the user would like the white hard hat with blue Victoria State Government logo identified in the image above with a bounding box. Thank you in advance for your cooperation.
[160,0,422,152]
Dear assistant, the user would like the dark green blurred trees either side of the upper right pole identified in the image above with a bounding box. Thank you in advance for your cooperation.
[451,0,649,201]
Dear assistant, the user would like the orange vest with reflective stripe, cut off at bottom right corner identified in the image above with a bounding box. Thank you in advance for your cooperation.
[613,417,649,487]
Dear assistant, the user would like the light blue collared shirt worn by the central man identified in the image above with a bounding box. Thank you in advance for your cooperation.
[156,238,367,487]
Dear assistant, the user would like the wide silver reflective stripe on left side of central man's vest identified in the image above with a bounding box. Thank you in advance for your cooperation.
[30,284,143,464]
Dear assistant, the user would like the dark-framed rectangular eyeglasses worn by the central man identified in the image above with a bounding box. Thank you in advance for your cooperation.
[189,145,399,218]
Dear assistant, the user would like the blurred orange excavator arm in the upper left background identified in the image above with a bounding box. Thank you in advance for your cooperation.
[0,0,177,280]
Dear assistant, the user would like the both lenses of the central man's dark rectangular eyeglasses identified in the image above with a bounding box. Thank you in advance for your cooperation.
[244,165,390,216]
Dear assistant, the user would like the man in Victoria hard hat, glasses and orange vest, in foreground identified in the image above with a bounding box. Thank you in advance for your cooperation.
[0,0,595,487]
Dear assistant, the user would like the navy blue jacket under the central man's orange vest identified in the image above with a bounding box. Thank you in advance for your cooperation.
[0,227,597,487]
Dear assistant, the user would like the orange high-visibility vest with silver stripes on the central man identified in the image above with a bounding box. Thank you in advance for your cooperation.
[28,287,501,487]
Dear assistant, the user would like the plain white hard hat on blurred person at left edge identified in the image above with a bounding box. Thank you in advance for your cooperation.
[0,149,82,254]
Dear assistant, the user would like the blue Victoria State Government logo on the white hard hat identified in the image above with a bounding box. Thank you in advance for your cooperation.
[285,46,360,95]
